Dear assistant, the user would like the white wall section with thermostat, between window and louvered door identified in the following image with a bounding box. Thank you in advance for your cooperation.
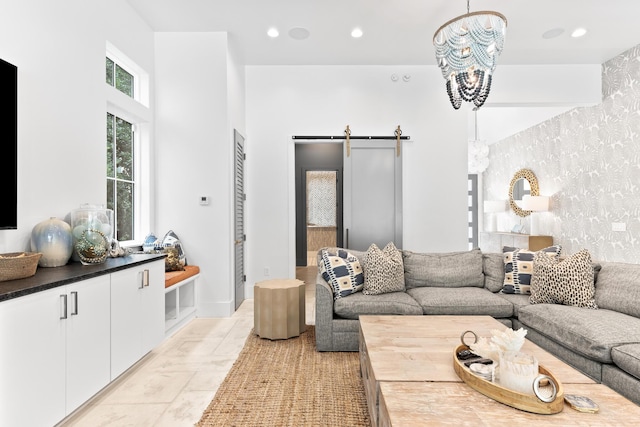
[155,33,239,316]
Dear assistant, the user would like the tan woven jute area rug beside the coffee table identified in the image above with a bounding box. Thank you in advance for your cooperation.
[197,326,370,427]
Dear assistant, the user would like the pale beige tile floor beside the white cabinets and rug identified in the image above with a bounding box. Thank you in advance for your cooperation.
[59,266,317,427]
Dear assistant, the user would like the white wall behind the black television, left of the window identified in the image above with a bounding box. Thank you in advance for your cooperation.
[0,0,106,252]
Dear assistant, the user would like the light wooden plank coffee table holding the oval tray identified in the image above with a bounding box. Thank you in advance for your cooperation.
[360,316,640,426]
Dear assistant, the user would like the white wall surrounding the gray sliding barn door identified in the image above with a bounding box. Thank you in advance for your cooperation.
[246,66,467,295]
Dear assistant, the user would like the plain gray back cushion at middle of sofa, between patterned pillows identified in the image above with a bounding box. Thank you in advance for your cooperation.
[402,249,484,289]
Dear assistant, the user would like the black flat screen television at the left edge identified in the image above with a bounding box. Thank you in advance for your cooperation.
[0,59,18,230]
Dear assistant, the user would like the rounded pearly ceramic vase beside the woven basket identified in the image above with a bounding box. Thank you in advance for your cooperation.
[31,217,73,267]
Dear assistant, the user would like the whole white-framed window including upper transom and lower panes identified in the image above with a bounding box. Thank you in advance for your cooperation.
[105,43,152,245]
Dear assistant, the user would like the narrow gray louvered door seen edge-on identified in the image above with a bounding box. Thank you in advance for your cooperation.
[233,129,246,310]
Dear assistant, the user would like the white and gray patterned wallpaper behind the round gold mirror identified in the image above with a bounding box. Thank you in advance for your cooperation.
[484,45,640,263]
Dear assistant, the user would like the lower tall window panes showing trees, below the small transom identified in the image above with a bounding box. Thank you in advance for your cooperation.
[107,113,135,241]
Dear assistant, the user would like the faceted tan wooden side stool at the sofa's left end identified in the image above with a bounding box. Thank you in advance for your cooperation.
[253,279,307,340]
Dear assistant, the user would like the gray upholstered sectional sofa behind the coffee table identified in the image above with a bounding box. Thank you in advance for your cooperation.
[315,249,640,404]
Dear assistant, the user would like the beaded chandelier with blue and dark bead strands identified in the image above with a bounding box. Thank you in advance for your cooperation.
[433,0,507,110]
